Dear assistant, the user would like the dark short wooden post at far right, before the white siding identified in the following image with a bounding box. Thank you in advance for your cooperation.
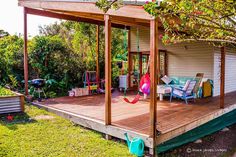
[220,47,225,108]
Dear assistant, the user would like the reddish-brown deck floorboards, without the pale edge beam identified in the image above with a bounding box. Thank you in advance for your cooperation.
[38,92,236,134]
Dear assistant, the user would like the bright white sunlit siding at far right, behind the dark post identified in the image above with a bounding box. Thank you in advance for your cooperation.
[214,48,236,96]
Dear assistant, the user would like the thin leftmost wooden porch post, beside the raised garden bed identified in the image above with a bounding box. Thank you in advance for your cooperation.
[24,7,29,95]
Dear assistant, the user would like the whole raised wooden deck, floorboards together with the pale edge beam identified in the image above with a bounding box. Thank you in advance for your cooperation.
[34,92,236,148]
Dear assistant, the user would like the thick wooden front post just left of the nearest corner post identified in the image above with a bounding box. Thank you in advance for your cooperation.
[104,14,111,125]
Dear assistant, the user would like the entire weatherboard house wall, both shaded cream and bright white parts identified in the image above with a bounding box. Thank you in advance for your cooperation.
[131,27,236,96]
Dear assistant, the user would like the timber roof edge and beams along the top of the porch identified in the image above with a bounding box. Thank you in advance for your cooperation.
[18,0,152,27]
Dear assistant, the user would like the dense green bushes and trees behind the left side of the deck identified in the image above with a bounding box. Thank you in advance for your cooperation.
[0,21,127,97]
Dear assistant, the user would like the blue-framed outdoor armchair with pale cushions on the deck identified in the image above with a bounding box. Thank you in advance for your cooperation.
[170,80,197,104]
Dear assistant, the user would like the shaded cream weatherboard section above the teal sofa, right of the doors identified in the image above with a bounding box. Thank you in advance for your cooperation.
[166,42,213,79]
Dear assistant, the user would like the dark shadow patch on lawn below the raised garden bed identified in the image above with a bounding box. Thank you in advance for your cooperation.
[0,112,37,130]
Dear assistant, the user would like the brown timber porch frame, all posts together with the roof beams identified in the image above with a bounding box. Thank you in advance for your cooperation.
[19,0,225,154]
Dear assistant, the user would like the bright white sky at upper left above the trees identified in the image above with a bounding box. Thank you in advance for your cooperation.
[0,0,59,36]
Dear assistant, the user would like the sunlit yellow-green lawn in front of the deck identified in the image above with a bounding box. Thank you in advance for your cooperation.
[0,106,131,157]
